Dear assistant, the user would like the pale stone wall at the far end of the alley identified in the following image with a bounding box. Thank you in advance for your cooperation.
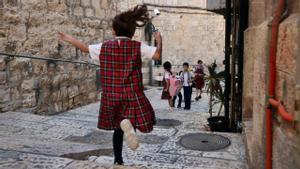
[119,0,225,84]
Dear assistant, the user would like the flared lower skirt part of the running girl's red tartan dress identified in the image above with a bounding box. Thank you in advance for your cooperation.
[98,92,155,133]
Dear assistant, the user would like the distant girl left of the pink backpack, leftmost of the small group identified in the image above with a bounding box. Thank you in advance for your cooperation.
[161,61,174,110]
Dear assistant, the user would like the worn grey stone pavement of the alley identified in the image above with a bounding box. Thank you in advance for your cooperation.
[0,88,247,169]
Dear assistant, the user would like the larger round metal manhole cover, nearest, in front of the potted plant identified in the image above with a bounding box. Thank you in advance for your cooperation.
[179,133,230,151]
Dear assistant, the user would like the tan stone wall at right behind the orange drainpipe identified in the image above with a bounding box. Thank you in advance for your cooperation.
[243,0,300,169]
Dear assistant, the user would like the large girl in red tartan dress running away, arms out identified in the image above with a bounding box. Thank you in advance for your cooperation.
[60,5,162,165]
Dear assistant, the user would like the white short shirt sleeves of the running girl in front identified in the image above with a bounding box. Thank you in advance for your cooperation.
[89,38,156,61]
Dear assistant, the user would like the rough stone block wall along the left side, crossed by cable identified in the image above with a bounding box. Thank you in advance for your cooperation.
[0,0,117,114]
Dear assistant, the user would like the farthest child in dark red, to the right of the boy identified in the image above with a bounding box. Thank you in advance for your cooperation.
[194,60,204,101]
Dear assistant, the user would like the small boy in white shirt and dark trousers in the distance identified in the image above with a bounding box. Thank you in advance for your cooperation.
[181,62,193,110]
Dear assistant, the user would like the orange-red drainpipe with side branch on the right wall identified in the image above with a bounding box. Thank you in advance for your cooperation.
[265,0,294,169]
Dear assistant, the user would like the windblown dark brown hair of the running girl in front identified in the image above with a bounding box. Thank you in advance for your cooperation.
[112,5,149,38]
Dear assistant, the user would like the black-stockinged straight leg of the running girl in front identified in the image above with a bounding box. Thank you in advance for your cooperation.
[113,129,124,165]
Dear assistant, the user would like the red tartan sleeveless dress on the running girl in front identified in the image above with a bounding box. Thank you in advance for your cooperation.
[98,38,155,133]
